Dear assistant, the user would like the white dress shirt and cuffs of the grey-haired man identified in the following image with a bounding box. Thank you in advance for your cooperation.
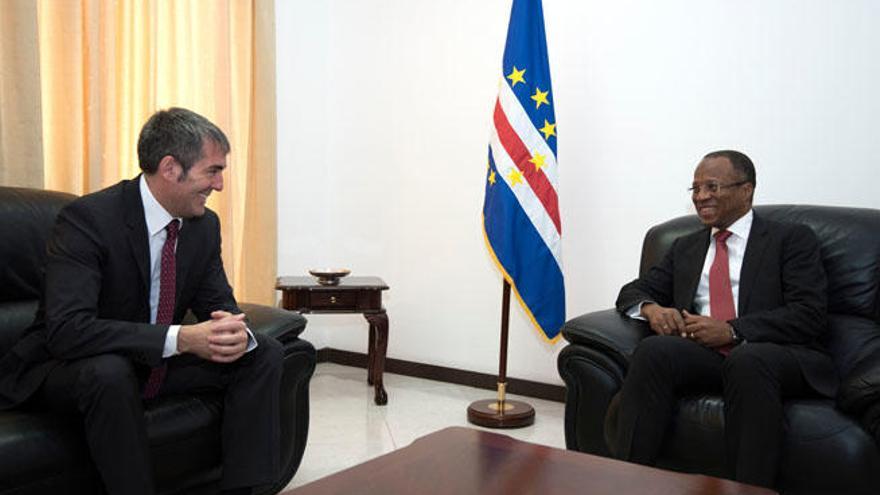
[140,175,257,358]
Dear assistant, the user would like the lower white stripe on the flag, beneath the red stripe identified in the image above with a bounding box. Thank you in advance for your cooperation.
[489,125,562,271]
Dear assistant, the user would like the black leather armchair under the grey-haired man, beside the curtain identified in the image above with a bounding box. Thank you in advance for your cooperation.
[0,187,316,495]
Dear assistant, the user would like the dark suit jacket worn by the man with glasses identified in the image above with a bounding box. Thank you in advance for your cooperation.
[616,214,837,396]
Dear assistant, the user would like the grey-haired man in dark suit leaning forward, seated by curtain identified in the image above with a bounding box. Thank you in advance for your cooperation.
[0,108,282,495]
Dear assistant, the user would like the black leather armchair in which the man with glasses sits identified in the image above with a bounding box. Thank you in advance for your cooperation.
[558,205,880,494]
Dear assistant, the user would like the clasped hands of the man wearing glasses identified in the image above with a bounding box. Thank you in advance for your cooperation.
[641,303,733,347]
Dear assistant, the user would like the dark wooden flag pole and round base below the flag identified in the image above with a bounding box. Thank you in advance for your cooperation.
[468,280,535,428]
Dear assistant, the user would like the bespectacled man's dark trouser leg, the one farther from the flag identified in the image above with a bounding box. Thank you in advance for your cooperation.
[723,342,811,487]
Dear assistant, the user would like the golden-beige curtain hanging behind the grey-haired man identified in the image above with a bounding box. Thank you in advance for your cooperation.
[0,0,276,304]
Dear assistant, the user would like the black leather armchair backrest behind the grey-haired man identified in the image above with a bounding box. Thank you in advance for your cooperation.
[0,186,76,355]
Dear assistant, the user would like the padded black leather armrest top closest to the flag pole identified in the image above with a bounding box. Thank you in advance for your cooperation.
[562,309,651,369]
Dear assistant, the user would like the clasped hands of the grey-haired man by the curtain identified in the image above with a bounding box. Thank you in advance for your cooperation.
[177,311,248,363]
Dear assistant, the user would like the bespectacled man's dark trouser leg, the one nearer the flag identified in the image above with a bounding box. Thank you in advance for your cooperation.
[611,335,723,465]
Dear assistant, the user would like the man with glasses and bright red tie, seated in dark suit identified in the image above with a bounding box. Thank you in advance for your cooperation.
[612,151,837,487]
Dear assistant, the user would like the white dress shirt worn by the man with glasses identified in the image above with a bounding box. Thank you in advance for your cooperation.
[626,209,755,320]
